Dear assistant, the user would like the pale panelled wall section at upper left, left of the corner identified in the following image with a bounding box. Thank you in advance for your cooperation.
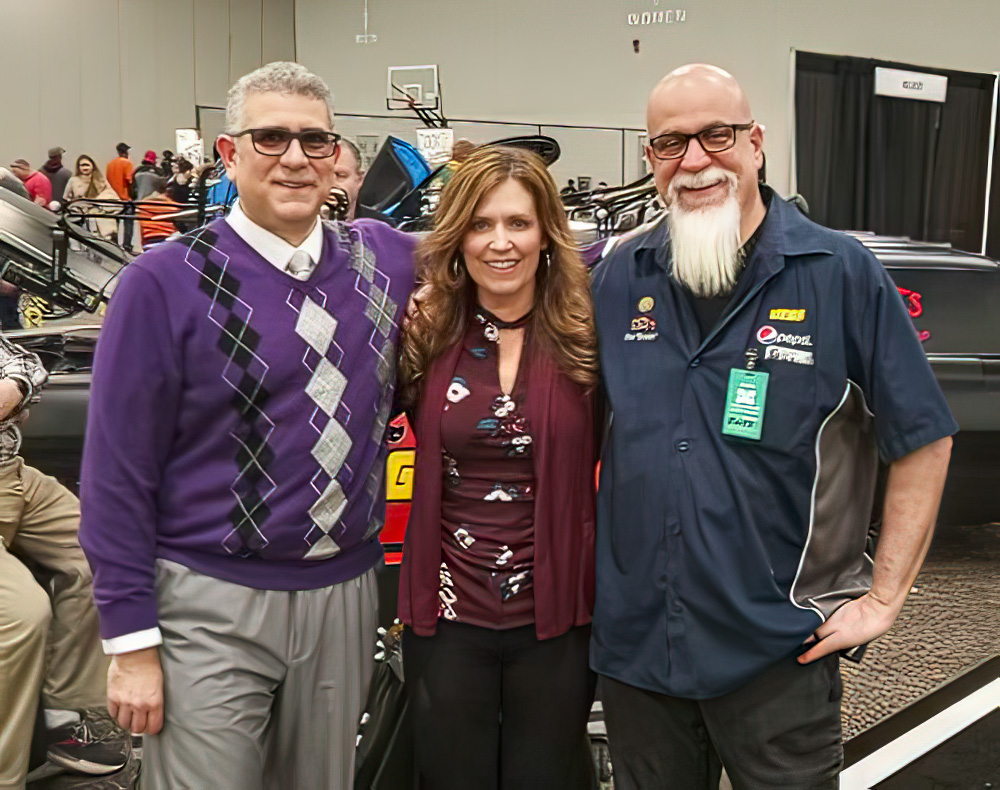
[0,0,295,178]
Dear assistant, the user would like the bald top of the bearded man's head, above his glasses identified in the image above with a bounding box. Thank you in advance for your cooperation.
[646,63,751,137]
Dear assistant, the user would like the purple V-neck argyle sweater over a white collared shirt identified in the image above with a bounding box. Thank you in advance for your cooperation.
[80,220,414,639]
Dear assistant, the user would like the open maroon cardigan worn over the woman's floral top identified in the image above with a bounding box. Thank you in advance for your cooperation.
[399,342,595,639]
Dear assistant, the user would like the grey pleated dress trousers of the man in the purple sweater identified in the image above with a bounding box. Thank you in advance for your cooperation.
[142,560,377,790]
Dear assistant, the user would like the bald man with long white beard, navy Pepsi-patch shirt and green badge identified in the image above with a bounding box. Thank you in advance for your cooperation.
[591,64,958,790]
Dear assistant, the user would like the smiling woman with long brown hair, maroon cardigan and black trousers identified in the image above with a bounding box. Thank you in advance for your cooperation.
[399,147,598,790]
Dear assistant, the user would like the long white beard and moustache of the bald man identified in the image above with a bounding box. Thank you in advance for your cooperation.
[667,168,743,298]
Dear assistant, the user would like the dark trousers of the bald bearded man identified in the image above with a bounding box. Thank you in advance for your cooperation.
[601,655,844,790]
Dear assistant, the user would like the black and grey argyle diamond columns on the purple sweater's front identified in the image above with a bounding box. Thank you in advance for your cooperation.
[182,224,401,560]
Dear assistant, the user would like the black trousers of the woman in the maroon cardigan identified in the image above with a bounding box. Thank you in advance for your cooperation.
[403,621,596,790]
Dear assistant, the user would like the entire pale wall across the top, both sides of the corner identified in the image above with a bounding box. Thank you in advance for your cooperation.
[7,0,1000,189]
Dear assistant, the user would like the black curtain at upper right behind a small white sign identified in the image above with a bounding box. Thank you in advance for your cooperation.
[795,52,994,252]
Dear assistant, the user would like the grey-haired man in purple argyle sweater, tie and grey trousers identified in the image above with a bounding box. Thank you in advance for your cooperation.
[80,63,414,790]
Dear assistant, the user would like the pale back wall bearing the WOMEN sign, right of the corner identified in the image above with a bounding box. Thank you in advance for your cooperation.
[296,0,1000,194]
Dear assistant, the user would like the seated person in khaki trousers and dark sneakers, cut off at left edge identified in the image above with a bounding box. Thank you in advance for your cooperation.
[0,336,125,789]
